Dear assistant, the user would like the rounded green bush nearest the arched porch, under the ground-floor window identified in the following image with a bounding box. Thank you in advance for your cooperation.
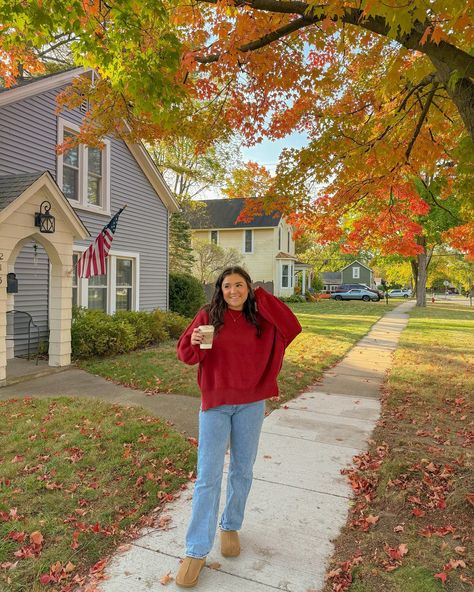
[71,310,137,358]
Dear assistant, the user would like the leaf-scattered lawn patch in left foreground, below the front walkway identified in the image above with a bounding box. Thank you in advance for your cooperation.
[0,398,196,592]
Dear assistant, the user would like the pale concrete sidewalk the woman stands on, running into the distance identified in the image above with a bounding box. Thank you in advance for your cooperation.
[101,301,414,592]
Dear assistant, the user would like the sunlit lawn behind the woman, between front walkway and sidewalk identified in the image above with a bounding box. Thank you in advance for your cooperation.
[80,300,400,407]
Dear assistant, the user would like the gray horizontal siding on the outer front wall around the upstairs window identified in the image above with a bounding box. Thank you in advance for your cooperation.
[0,90,168,310]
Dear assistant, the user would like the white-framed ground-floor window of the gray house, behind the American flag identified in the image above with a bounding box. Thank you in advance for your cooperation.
[72,251,140,314]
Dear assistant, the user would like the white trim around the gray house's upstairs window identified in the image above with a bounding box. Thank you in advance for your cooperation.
[56,117,111,214]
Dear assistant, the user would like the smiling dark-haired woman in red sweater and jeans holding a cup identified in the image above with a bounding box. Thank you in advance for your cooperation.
[176,267,301,588]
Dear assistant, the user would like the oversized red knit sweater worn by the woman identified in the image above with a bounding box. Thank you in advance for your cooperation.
[177,288,301,411]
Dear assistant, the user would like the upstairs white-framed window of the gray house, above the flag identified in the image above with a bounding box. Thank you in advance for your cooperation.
[57,119,110,213]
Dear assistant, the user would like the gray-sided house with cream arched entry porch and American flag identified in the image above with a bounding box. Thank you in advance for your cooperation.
[0,68,178,384]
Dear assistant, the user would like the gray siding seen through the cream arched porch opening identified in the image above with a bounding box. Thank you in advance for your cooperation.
[14,242,49,356]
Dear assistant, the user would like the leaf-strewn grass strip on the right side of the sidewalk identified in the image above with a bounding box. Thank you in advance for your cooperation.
[324,302,474,592]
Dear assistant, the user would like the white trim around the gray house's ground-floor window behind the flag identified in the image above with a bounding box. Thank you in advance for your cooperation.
[73,245,140,314]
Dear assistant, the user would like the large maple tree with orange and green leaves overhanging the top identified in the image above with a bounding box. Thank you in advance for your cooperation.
[0,0,474,292]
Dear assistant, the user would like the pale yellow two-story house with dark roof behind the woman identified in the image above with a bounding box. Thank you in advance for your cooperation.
[190,198,297,296]
